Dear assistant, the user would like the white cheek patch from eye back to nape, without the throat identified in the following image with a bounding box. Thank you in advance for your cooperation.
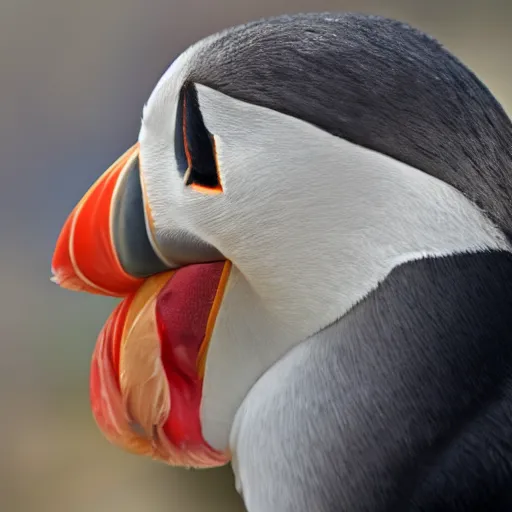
[192,85,508,318]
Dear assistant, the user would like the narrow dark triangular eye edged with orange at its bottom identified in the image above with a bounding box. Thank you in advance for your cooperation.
[174,84,222,194]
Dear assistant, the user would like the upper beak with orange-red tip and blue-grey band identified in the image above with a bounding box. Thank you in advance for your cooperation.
[52,144,169,297]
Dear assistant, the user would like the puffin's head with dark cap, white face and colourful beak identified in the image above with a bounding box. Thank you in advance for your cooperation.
[53,14,512,467]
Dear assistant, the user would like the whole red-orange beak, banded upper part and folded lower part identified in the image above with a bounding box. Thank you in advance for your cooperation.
[52,144,231,467]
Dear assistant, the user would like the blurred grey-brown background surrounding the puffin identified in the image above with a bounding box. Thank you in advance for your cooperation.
[0,0,512,512]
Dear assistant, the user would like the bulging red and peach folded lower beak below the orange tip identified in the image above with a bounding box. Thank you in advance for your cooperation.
[90,261,231,467]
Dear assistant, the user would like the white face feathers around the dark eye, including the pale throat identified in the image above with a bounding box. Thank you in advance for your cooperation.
[139,43,509,449]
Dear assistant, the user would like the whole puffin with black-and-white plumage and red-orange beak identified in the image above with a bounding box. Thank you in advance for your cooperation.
[52,13,512,512]
